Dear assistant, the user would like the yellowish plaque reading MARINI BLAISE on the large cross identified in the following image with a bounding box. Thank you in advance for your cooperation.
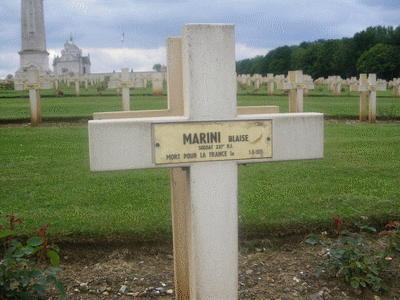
[152,121,272,164]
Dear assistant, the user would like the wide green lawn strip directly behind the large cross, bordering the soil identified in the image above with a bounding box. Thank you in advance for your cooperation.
[0,123,400,240]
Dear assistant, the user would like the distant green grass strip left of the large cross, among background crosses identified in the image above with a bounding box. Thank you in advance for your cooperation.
[0,84,168,122]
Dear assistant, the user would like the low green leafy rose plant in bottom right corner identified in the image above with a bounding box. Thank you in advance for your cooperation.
[314,214,400,292]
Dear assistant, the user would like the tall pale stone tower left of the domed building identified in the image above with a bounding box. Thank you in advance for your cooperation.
[16,0,51,76]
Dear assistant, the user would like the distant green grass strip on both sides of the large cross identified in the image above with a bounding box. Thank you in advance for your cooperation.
[0,85,400,122]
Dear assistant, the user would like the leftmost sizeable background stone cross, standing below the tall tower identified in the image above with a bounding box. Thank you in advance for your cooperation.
[15,69,53,126]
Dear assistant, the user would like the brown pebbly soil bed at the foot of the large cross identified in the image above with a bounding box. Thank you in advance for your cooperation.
[43,237,400,300]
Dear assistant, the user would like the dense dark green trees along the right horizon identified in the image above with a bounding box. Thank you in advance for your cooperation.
[236,26,400,80]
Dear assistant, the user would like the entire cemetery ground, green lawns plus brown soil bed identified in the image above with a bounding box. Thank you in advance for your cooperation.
[0,82,400,299]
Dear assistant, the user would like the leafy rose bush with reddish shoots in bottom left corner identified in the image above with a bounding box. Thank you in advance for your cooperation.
[0,214,66,300]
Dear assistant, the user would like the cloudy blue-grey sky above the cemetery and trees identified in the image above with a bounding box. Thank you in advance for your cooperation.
[0,0,400,78]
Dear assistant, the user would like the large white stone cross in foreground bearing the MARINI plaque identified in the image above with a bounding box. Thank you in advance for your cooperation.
[89,24,323,299]
